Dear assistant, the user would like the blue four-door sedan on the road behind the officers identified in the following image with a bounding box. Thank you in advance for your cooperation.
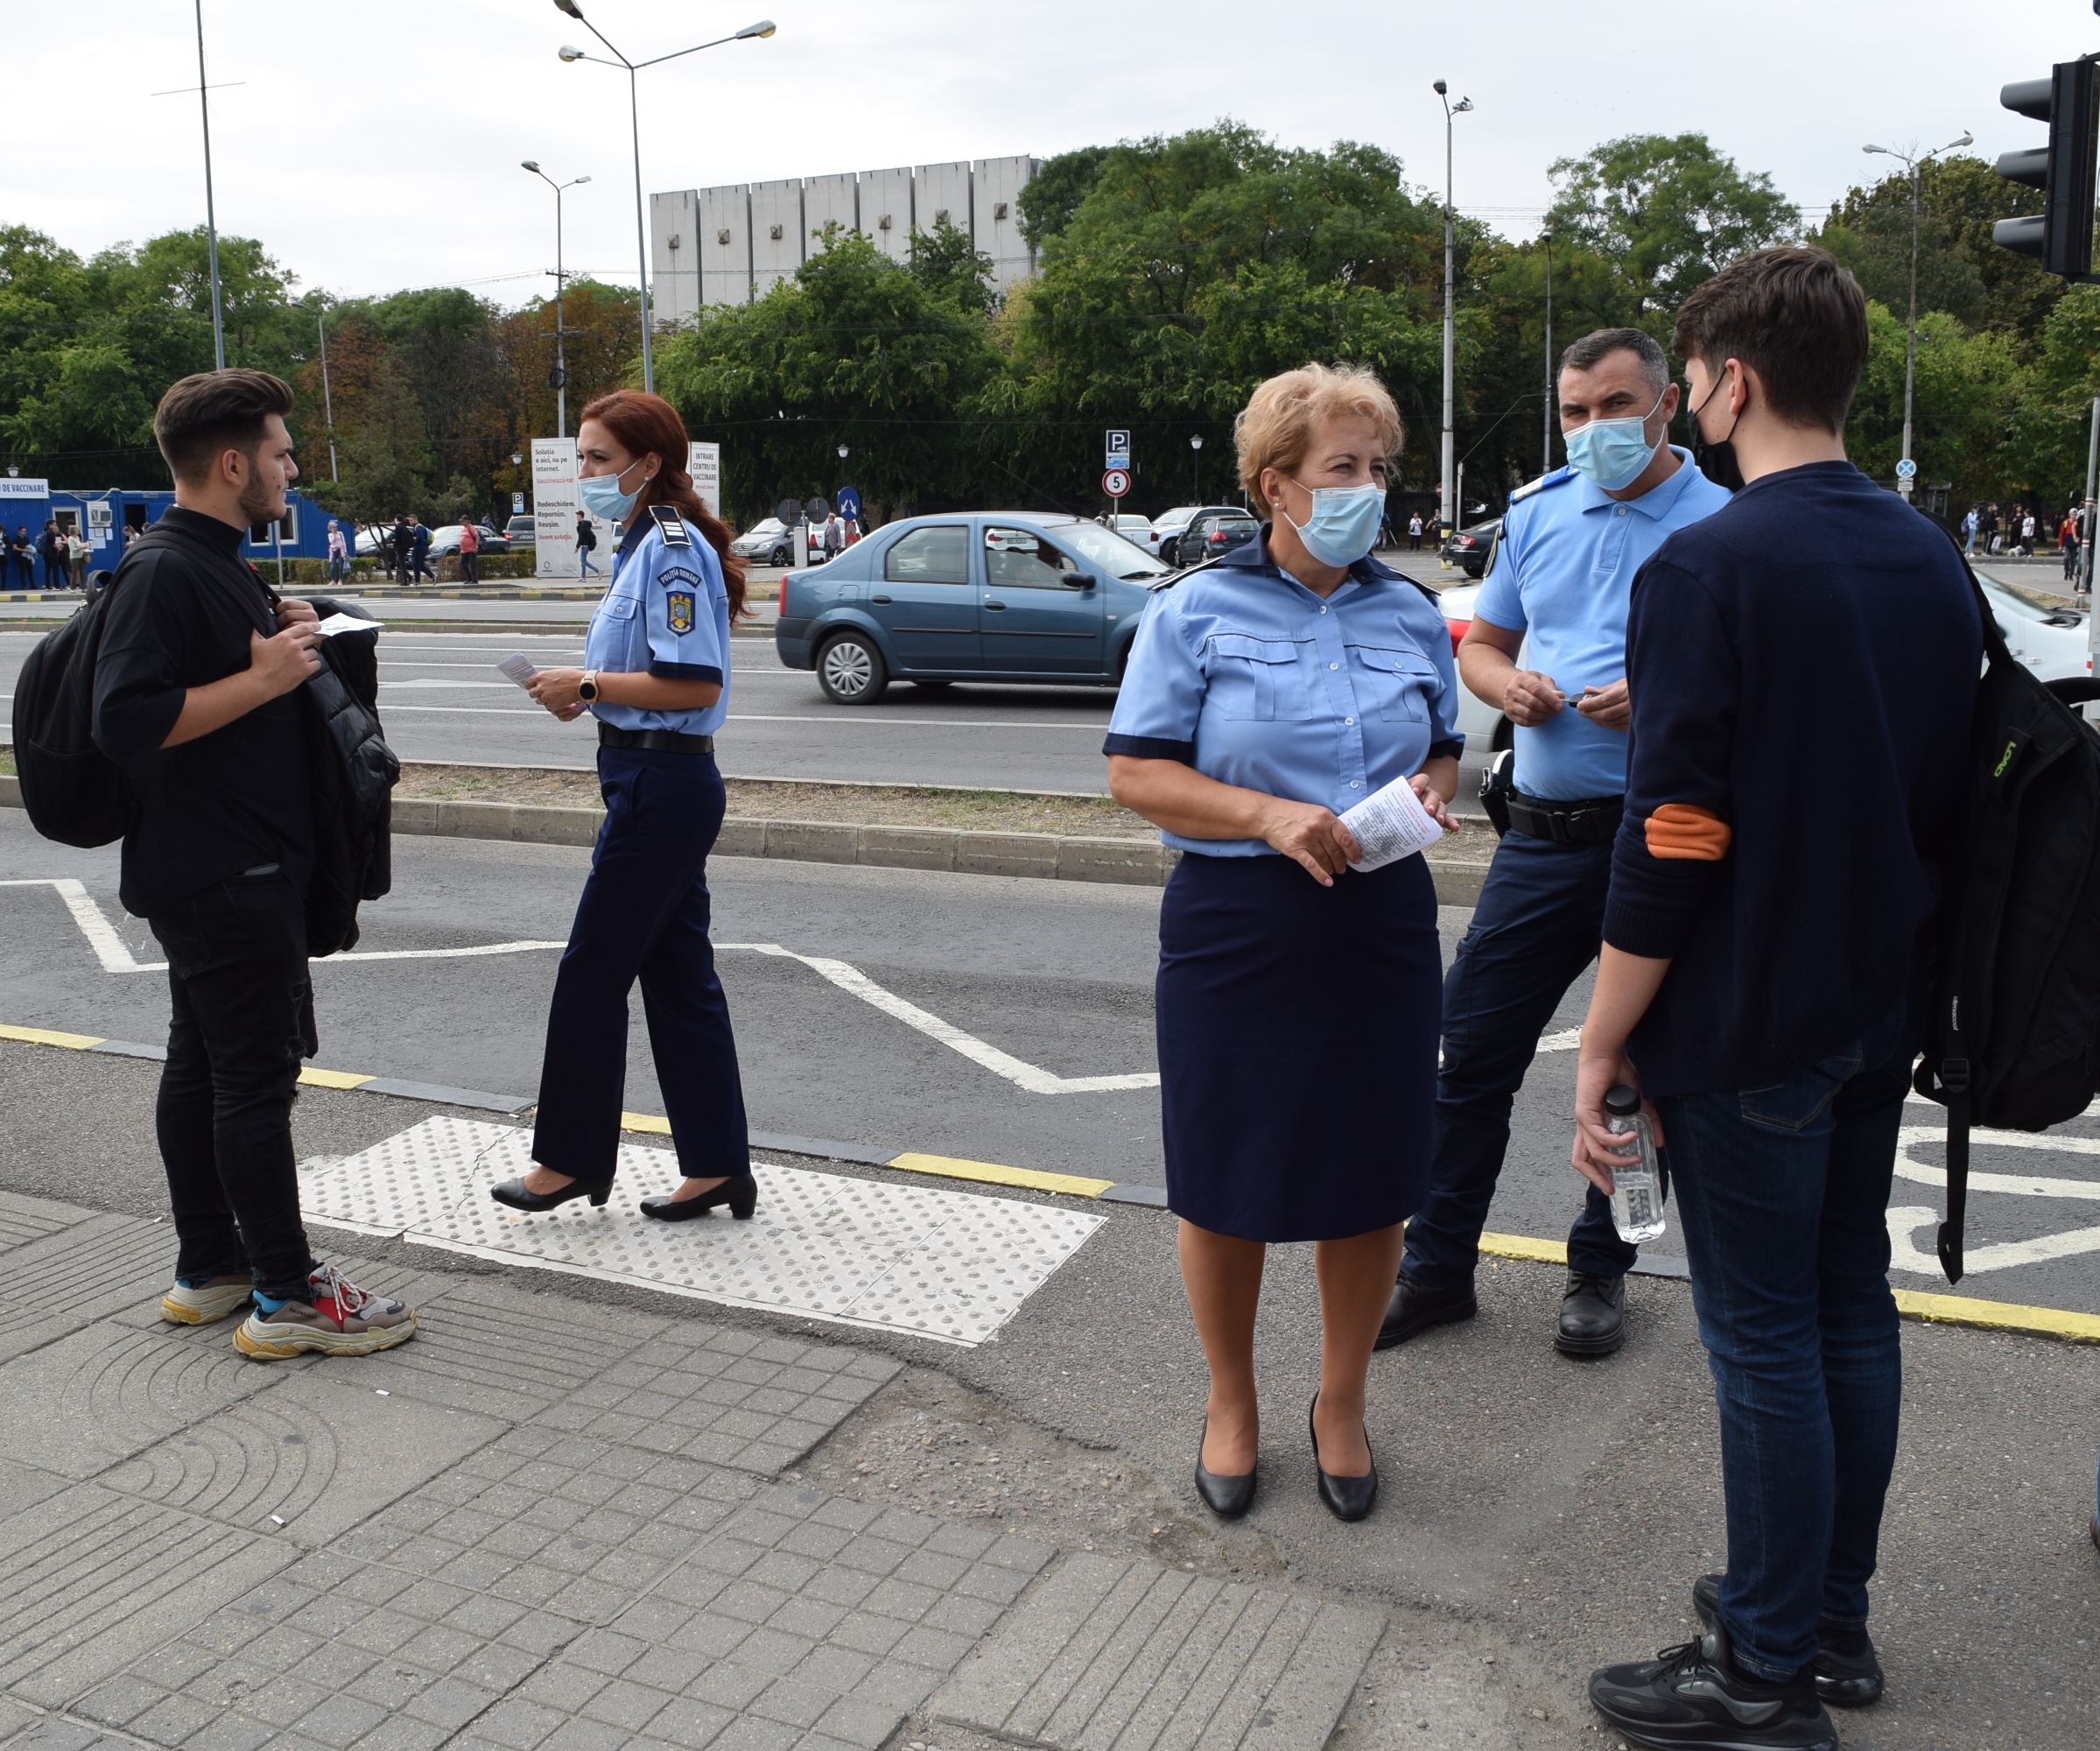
[773,510,1168,706]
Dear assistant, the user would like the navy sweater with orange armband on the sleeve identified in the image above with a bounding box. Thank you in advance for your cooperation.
[1605,462,1983,1093]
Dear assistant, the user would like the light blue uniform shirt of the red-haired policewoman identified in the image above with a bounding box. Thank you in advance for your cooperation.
[584,503,728,735]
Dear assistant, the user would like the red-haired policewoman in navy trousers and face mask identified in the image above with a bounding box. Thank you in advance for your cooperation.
[494,390,758,1222]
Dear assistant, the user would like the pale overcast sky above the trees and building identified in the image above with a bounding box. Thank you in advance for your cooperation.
[0,0,2100,305]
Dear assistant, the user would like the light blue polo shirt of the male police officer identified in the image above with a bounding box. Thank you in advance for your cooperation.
[1472,445,1728,802]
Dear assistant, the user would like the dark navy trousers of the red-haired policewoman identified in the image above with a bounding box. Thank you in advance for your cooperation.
[531,748,752,1180]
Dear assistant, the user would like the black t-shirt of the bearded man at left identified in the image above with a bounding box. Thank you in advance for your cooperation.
[95,506,313,918]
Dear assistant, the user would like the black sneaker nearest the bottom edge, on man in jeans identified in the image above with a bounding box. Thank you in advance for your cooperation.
[1590,1628,1837,1751]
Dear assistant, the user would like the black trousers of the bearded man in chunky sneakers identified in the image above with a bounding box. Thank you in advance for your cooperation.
[149,874,320,1299]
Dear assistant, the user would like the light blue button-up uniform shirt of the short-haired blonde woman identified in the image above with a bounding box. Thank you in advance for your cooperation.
[1102,529,1464,856]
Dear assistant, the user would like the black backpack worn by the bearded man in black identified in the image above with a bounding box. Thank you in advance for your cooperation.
[15,554,127,846]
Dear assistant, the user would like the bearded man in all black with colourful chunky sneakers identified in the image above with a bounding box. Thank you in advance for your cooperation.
[93,369,416,1359]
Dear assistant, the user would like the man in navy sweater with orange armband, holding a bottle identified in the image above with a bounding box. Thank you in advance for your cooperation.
[1575,248,1983,1751]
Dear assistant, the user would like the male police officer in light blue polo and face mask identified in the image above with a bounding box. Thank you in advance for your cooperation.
[1378,327,1728,1356]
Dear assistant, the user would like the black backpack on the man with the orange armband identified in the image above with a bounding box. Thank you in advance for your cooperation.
[1915,518,2100,1283]
